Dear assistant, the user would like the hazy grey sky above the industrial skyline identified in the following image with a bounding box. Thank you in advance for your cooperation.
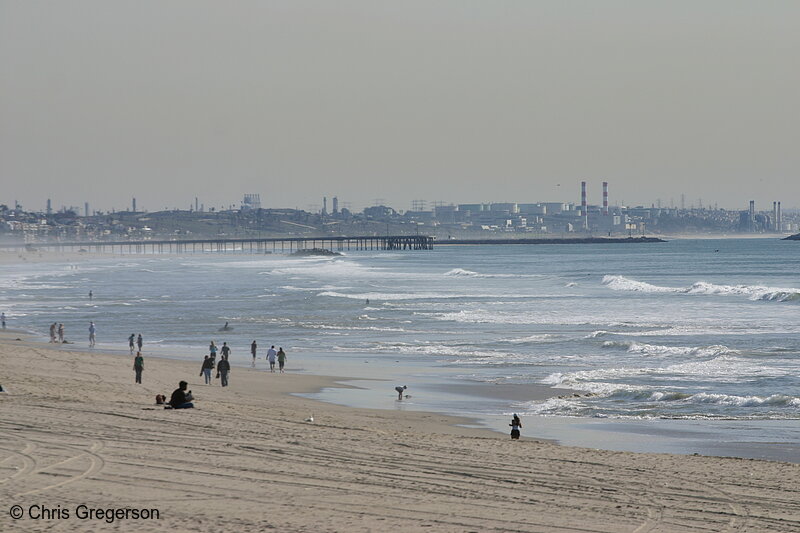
[0,0,800,210]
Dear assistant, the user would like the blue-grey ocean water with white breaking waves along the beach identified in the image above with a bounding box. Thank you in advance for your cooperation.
[0,239,800,458]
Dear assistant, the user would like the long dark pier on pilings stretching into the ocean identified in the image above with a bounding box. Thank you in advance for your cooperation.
[0,235,435,254]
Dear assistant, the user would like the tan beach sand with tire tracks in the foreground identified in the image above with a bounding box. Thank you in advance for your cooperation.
[0,334,800,533]
